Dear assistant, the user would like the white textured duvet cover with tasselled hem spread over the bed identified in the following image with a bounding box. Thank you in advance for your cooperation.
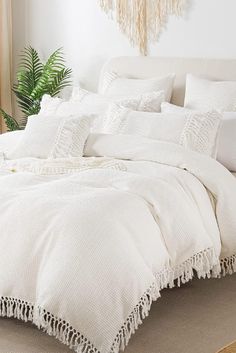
[0,134,236,353]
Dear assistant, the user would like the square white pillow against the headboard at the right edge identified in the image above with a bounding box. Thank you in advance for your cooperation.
[184,74,236,112]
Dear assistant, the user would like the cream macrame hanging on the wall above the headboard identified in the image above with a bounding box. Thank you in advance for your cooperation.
[99,0,187,55]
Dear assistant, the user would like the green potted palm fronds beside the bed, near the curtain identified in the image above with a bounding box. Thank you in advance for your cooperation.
[0,47,72,130]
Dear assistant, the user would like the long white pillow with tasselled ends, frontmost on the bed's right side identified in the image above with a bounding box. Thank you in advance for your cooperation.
[103,104,221,156]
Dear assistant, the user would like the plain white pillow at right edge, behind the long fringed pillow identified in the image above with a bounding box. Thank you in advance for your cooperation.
[161,103,236,172]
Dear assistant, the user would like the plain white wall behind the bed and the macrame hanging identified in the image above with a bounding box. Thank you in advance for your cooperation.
[13,0,236,89]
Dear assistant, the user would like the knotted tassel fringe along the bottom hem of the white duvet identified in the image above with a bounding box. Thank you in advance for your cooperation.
[0,248,236,353]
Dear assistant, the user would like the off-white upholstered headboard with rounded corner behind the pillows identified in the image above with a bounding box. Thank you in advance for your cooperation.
[100,56,236,105]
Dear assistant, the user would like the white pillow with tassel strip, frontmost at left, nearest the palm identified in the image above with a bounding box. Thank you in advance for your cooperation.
[7,115,91,159]
